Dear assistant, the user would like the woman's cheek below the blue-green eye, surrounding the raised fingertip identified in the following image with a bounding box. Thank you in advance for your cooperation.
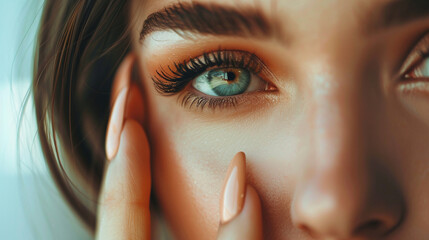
[144,93,302,239]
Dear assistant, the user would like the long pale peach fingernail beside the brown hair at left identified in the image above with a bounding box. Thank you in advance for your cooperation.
[106,87,128,160]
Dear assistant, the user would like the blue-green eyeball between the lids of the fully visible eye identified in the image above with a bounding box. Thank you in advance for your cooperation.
[192,68,268,96]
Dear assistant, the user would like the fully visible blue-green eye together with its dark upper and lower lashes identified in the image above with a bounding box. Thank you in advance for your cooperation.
[152,49,276,109]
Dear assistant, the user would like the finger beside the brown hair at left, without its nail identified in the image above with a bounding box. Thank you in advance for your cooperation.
[96,120,151,240]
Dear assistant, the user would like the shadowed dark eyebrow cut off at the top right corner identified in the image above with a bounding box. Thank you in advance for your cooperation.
[368,0,429,33]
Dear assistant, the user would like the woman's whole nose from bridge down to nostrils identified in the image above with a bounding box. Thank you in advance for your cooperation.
[291,65,401,239]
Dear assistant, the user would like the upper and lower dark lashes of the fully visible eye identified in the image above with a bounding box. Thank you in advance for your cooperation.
[152,50,266,109]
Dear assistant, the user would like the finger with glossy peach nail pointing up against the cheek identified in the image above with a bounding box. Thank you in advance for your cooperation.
[217,153,263,240]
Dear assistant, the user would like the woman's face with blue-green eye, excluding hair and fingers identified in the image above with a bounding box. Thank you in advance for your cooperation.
[132,0,429,239]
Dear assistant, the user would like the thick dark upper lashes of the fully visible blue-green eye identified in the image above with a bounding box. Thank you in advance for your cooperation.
[152,50,263,95]
